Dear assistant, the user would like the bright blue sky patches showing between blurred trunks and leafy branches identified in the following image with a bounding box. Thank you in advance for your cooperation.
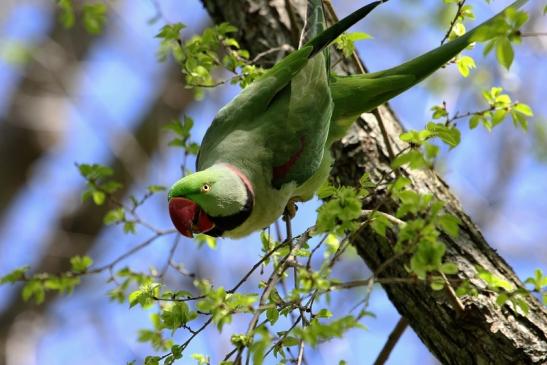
[0,0,547,365]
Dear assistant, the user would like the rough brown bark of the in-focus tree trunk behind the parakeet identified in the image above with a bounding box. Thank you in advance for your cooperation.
[202,0,547,364]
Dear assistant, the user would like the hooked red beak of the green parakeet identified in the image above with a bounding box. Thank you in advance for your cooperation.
[169,198,215,237]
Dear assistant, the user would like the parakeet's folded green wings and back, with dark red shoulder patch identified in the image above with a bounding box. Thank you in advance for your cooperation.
[197,0,381,188]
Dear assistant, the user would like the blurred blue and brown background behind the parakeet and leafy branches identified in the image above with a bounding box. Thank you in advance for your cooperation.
[0,0,547,365]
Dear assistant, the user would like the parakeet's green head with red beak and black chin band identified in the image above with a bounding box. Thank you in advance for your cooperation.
[168,164,254,237]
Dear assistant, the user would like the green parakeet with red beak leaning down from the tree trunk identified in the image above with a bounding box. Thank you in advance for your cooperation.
[168,0,526,238]
